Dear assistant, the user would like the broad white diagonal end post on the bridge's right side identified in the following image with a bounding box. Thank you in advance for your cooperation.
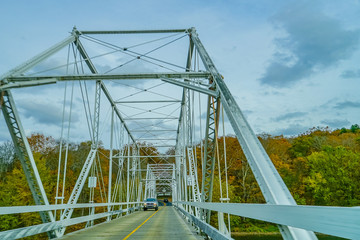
[190,28,317,240]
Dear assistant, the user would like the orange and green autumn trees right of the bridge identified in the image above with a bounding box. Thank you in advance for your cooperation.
[205,124,360,232]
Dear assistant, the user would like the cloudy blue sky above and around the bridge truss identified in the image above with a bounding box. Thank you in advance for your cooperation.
[0,0,360,144]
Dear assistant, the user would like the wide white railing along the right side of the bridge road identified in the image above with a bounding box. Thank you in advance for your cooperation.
[176,202,360,239]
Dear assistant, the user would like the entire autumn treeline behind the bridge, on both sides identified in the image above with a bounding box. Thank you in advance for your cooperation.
[0,124,360,234]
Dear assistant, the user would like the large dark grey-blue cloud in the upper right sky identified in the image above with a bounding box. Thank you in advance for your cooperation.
[260,1,360,87]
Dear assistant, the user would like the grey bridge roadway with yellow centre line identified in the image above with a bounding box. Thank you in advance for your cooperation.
[61,207,202,240]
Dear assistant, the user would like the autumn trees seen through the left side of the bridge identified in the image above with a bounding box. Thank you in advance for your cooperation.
[0,133,158,239]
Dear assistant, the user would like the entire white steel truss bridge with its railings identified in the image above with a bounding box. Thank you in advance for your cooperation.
[0,28,360,240]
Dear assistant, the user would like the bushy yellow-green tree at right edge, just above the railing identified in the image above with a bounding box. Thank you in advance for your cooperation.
[305,146,360,206]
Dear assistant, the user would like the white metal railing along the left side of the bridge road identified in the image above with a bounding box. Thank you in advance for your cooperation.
[0,202,141,239]
